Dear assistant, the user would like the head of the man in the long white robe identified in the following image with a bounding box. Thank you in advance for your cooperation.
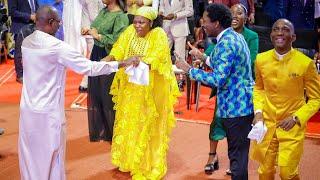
[36,6,61,35]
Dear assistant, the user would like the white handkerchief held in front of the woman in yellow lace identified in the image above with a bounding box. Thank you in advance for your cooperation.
[125,62,149,85]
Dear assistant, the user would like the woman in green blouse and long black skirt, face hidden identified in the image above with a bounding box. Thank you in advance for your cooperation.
[81,0,129,142]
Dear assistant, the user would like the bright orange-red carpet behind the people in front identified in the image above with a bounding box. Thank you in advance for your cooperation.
[0,60,320,137]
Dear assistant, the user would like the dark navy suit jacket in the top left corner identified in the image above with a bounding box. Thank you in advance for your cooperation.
[8,0,39,34]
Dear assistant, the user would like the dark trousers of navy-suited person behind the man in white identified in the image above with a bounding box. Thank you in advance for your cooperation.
[14,34,23,78]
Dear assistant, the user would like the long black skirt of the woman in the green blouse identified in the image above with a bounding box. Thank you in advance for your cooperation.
[87,45,115,142]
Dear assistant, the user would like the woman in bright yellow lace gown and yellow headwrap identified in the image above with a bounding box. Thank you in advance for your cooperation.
[110,7,179,179]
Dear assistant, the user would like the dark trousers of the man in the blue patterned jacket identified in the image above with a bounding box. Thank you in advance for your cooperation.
[223,114,254,180]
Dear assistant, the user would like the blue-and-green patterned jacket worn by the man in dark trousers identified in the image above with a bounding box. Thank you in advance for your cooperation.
[189,28,254,118]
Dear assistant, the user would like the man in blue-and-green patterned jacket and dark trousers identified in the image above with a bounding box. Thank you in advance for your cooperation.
[176,4,254,180]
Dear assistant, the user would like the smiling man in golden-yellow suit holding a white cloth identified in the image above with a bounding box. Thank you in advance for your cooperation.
[251,19,320,180]
